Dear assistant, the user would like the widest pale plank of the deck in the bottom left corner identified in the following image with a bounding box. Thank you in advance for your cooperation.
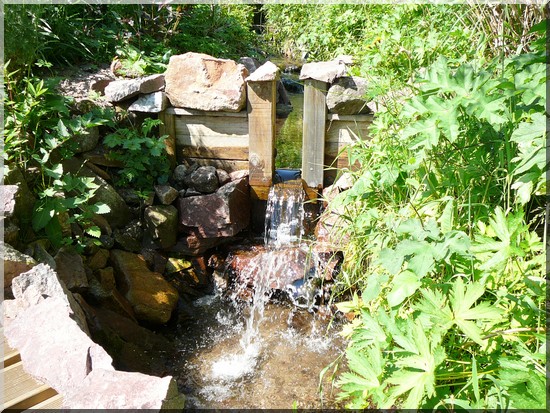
[2,361,57,410]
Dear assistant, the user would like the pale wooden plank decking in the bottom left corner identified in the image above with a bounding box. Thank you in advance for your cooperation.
[0,334,63,412]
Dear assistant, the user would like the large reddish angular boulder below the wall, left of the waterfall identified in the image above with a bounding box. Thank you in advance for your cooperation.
[178,178,250,238]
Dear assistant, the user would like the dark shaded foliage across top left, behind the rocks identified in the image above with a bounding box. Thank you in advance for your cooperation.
[4,4,255,72]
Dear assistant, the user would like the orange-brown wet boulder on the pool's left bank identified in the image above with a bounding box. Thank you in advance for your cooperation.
[111,250,178,324]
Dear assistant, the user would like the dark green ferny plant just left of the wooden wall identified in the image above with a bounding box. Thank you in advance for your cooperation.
[103,118,170,190]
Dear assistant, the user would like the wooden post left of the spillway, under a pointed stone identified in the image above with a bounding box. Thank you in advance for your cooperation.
[247,80,277,187]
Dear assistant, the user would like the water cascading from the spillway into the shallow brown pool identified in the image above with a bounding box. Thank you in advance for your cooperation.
[172,180,342,409]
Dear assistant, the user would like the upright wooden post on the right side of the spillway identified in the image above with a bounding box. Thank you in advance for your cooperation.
[302,79,328,188]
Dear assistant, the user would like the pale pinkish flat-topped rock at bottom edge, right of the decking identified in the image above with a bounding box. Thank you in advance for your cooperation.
[63,369,185,411]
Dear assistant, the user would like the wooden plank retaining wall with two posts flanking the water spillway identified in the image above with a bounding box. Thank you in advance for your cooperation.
[160,79,372,200]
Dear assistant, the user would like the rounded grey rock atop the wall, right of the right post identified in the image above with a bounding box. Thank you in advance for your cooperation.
[327,76,370,115]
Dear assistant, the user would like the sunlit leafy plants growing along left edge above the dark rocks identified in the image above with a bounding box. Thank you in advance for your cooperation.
[3,64,111,247]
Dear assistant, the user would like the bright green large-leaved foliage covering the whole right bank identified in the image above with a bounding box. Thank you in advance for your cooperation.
[330,26,548,410]
